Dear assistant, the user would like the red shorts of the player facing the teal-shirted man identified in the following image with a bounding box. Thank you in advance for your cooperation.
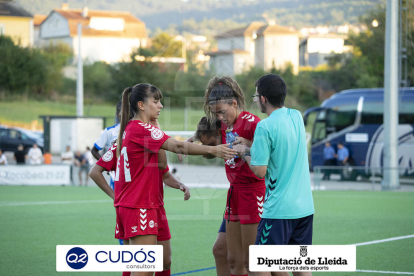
[224,182,266,224]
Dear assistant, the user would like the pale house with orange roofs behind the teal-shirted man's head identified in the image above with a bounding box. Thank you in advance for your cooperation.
[206,22,299,76]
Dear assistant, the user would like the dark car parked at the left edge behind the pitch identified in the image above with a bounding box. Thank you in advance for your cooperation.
[0,126,43,152]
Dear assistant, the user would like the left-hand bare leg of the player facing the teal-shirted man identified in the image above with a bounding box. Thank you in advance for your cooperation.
[226,221,247,275]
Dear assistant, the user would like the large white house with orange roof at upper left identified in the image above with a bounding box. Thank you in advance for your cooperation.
[40,4,148,63]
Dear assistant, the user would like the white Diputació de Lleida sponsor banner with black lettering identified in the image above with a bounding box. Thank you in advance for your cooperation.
[249,245,356,272]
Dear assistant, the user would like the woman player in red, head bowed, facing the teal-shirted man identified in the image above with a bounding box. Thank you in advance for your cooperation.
[204,77,266,275]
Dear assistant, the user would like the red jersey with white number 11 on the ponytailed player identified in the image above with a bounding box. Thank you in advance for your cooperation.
[114,120,170,209]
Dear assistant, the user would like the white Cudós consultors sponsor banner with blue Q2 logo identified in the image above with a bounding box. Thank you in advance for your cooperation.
[56,245,163,272]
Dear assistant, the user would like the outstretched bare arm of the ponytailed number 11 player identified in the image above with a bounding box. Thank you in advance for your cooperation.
[161,138,236,159]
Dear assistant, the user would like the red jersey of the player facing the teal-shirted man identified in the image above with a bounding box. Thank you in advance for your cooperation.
[221,111,265,186]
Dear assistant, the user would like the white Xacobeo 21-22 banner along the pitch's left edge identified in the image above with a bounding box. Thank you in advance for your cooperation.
[0,165,70,185]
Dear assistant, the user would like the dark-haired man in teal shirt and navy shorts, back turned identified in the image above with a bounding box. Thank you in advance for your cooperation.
[234,74,315,252]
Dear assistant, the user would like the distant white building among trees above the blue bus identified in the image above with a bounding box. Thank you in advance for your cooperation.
[299,34,350,68]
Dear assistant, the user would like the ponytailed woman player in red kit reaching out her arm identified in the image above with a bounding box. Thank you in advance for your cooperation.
[114,84,236,276]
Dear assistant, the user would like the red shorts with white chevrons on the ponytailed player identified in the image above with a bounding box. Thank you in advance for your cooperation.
[115,206,158,240]
